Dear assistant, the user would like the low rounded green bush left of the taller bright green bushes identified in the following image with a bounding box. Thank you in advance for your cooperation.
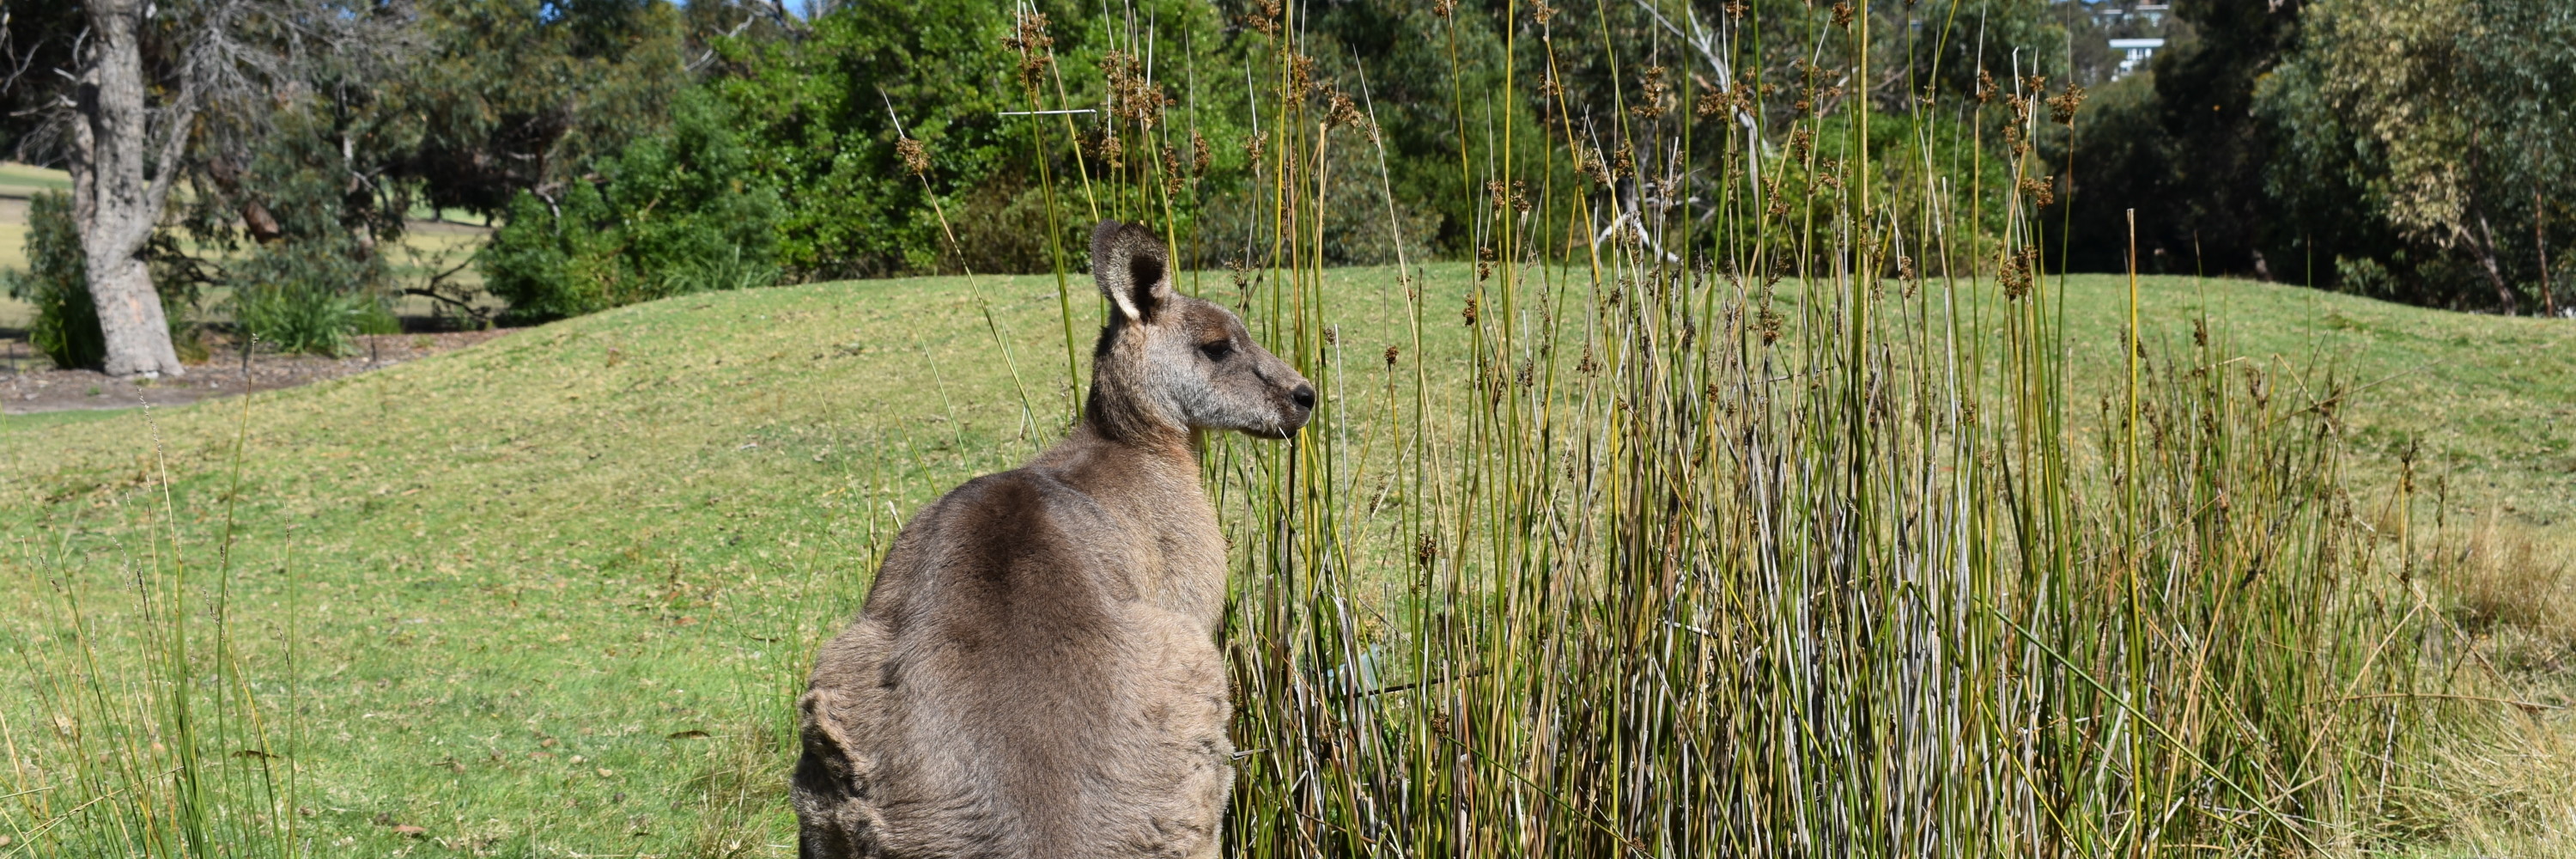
[479,93,778,322]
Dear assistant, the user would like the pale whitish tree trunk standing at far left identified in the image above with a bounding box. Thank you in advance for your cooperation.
[70,0,193,376]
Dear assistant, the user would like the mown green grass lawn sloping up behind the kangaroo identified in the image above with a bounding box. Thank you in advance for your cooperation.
[0,265,2576,856]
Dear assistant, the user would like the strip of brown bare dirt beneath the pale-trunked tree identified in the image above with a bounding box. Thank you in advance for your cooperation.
[0,330,510,415]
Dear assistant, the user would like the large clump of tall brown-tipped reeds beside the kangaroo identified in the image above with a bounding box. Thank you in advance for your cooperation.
[1015,3,2432,856]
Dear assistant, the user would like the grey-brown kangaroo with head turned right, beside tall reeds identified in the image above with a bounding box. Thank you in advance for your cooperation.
[788,222,1314,859]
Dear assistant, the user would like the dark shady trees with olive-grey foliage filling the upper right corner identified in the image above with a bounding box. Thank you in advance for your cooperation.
[2045,0,2576,309]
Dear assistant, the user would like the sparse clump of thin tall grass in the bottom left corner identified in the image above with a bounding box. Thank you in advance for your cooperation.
[0,397,312,859]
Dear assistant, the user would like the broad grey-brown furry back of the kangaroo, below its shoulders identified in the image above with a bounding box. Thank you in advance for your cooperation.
[796,470,1195,856]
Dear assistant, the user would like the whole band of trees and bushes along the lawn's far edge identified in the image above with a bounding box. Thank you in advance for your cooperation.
[0,0,2576,350]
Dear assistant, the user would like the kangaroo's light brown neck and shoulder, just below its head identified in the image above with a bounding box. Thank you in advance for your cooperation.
[1030,420,1226,618]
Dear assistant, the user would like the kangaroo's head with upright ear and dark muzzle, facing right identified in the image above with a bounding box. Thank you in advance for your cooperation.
[1084,222,1314,439]
